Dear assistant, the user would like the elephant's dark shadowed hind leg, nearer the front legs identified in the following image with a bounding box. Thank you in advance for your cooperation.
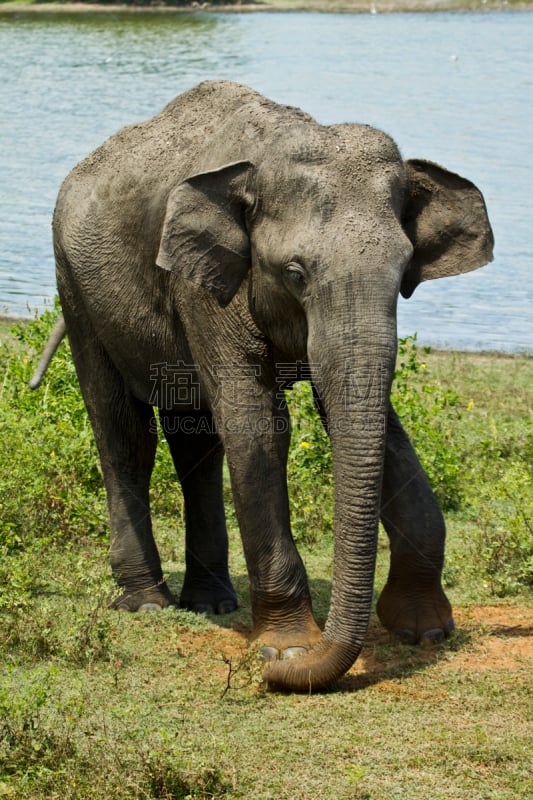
[160,411,237,614]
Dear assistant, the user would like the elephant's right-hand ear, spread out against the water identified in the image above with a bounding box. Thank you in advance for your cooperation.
[401,160,494,297]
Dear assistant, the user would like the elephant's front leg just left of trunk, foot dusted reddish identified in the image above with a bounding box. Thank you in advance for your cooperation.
[219,391,320,659]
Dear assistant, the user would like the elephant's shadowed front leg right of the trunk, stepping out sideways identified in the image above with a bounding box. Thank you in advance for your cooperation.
[377,407,454,644]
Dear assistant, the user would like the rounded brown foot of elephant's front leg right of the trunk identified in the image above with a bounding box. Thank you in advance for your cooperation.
[377,578,455,646]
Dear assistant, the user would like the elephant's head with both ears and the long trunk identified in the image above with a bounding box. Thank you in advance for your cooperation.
[157,120,493,690]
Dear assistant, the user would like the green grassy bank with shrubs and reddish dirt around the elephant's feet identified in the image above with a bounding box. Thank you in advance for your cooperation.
[0,315,533,800]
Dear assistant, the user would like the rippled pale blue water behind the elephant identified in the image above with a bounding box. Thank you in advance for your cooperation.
[0,12,533,351]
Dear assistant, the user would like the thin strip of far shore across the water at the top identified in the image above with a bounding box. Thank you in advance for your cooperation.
[0,0,533,17]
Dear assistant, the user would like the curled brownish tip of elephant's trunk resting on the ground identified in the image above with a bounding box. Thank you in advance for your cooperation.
[263,636,362,694]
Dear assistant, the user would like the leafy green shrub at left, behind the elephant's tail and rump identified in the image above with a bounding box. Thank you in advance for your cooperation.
[0,305,106,550]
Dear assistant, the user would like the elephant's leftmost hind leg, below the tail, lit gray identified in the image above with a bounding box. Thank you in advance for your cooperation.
[65,316,175,611]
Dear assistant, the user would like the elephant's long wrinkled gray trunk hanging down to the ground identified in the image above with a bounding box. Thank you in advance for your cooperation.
[265,290,396,691]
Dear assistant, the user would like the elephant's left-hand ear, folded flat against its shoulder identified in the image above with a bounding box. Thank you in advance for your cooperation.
[156,161,254,307]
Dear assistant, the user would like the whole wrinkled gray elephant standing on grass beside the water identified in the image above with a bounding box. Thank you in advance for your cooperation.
[46,82,492,691]
